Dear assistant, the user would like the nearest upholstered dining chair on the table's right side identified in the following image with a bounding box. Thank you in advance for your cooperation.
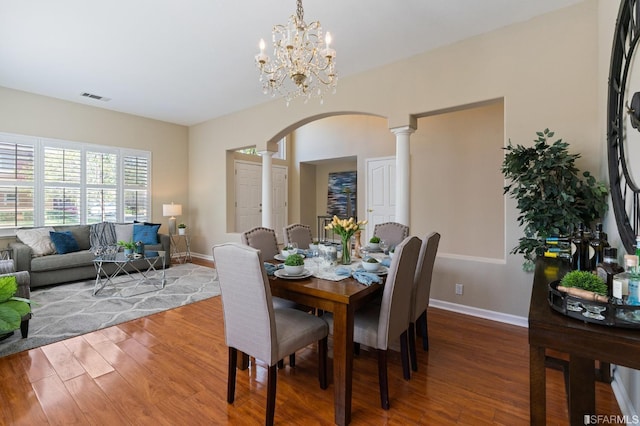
[323,237,420,410]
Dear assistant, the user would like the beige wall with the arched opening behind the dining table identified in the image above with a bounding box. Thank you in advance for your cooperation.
[189,1,606,317]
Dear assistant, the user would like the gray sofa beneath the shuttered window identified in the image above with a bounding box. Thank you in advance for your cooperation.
[9,225,171,288]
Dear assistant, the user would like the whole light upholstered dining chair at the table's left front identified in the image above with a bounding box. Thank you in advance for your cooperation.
[213,243,329,425]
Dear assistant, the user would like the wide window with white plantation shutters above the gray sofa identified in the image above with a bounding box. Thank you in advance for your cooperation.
[0,133,151,234]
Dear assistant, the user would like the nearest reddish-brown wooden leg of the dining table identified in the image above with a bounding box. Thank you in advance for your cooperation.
[333,305,353,425]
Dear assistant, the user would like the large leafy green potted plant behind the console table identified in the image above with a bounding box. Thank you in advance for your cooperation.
[501,129,608,271]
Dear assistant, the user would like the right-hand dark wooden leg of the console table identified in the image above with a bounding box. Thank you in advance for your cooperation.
[569,355,596,425]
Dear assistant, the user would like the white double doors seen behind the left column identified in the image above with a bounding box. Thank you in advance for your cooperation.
[235,161,288,238]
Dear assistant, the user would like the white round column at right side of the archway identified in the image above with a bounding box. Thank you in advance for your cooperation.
[391,126,416,226]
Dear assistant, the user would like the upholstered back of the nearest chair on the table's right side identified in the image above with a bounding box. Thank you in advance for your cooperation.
[378,237,420,349]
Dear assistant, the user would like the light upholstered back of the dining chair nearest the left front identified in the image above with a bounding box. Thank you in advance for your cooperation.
[213,243,278,365]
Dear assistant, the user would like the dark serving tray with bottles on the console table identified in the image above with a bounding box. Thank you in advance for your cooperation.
[549,280,640,328]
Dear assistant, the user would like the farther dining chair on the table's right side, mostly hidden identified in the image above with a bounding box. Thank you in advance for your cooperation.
[409,232,440,371]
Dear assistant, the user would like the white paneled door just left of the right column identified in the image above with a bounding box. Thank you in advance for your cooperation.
[362,157,396,243]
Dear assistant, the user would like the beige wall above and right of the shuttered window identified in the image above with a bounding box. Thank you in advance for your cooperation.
[0,87,189,232]
